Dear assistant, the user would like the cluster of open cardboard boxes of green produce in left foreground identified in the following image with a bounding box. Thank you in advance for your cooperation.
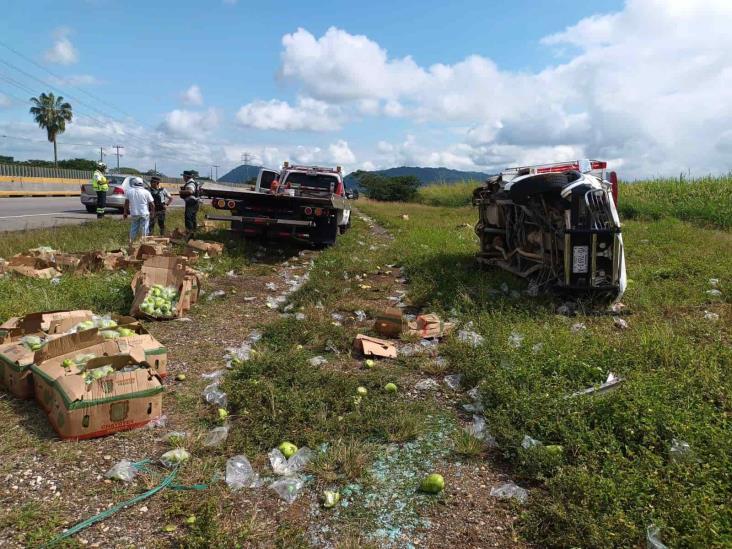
[0,311,167,439]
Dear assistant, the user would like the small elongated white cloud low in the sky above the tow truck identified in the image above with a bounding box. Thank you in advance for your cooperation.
[236,97,341,131]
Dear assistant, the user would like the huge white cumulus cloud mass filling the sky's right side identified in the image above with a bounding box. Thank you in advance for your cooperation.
[272,0,732,177]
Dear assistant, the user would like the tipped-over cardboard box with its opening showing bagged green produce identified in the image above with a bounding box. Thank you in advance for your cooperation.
[130,256,198,320]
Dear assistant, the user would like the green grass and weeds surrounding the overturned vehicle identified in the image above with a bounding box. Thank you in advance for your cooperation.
[360,198,732,547]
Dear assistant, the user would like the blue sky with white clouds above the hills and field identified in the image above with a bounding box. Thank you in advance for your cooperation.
[0,0,732,176]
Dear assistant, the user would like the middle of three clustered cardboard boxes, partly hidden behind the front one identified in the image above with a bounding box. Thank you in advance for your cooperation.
[29,323,168,411]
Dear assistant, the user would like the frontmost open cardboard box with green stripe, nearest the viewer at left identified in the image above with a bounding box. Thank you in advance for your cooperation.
[42,354,163,440]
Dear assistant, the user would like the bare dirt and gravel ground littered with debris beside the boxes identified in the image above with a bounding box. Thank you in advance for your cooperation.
[0,213,520,547]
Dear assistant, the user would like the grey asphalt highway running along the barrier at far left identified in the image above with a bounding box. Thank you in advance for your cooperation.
[0,196,182,232]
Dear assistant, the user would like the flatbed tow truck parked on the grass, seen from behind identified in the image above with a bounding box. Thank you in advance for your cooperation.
[201,162,351,246]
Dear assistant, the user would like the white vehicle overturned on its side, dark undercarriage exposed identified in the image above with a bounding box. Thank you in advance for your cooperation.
[473,159,627,300]
